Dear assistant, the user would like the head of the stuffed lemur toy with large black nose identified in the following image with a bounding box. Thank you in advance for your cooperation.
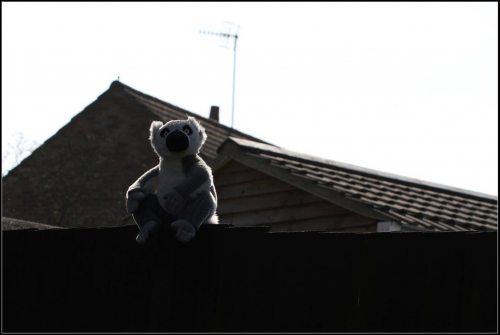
[149,116,207,158]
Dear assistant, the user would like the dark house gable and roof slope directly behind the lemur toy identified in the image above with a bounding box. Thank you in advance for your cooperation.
[2,81,268,227]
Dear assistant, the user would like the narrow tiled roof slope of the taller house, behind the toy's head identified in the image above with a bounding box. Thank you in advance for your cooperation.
[111,81,266,159]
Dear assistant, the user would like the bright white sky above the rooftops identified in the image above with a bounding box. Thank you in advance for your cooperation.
[2,2,498,195]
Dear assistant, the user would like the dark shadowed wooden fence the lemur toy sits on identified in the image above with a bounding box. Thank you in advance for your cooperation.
[3,226,497,332]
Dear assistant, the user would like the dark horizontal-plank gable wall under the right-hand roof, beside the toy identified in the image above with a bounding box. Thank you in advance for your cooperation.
[214,161,377,232]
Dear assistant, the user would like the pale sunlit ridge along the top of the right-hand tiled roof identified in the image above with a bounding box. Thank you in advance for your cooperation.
[228,136,498,202]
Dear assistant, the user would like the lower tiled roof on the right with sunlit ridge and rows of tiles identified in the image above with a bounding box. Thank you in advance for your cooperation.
[217,138,498,231]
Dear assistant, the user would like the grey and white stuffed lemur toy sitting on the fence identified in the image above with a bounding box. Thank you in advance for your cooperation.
[126,117,218,244]
